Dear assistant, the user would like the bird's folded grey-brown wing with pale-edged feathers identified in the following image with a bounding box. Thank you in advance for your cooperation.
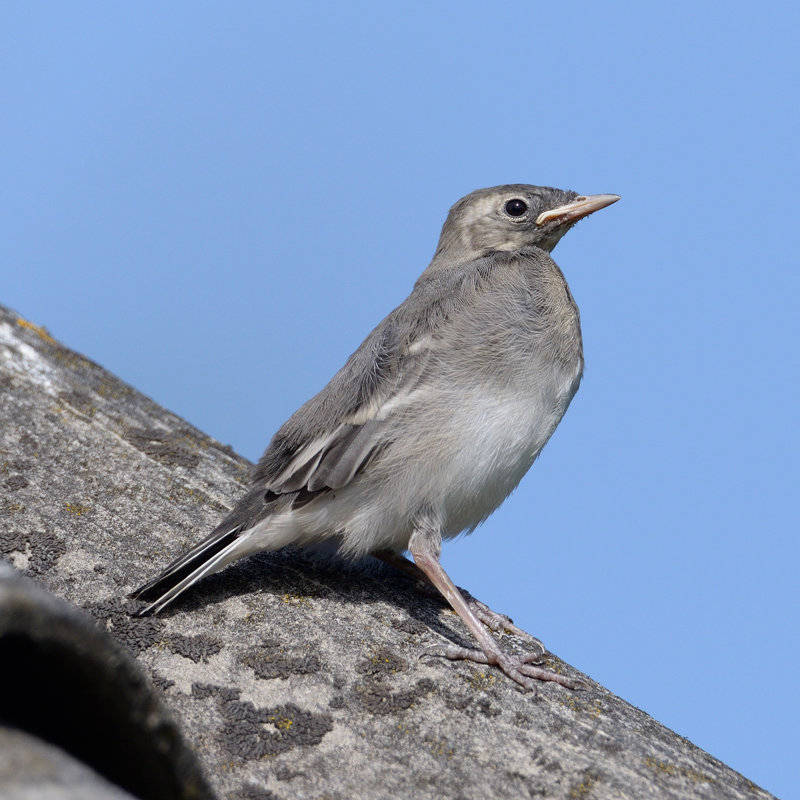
[254,254,519,504]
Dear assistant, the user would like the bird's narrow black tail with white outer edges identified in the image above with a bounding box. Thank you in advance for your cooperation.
[128,525,249,617]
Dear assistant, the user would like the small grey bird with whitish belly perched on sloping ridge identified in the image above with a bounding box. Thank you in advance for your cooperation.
[131,184,619,689]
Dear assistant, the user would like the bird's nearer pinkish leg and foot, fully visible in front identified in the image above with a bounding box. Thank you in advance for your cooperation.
[409,521,583,691]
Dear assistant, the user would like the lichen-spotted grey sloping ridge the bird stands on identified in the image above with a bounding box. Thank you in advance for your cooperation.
[0,307,771,800]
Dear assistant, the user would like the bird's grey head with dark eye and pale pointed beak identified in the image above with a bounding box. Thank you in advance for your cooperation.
[431,183,619,266]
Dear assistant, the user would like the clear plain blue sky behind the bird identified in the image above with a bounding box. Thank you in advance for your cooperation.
[0,0,800,797]
